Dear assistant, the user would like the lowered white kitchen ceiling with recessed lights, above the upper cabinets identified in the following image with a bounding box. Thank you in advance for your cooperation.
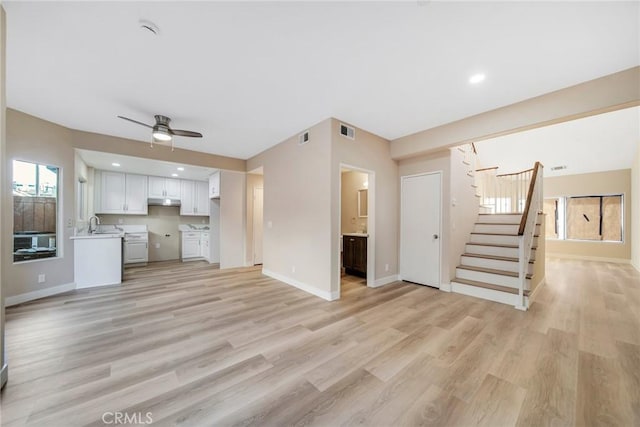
[76,150,217,181]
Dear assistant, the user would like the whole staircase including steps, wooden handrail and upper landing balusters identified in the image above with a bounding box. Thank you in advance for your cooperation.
[451,157,544,310]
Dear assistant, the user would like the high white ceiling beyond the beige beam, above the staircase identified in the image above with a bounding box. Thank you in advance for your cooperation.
[475,107,640,176]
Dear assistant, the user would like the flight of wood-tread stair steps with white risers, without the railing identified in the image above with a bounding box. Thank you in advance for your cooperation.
[451,213,543,307]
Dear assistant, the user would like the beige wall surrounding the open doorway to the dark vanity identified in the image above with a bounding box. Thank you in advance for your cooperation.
[329,119,400,293]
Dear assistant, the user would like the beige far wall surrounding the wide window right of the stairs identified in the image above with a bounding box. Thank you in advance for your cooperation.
[544,169,634,261]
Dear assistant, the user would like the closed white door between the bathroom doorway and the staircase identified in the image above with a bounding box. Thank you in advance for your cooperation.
[400,172,442,288]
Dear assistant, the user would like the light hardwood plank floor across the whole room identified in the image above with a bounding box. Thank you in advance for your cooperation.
[0,260,640,426]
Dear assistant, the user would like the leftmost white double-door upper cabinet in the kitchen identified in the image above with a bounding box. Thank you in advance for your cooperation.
[95,171,148,215]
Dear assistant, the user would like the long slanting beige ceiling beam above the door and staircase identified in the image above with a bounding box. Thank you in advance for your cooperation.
[391,67,640,160]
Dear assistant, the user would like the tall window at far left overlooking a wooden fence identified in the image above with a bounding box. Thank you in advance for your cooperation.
[12,160,60,262]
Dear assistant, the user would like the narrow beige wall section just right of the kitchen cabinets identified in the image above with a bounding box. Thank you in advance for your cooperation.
[220,170,247,268]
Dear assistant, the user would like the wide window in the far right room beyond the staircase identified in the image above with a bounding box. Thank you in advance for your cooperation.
[544,194,623,242]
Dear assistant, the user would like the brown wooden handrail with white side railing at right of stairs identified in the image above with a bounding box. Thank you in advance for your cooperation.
[516,162,544,310]
